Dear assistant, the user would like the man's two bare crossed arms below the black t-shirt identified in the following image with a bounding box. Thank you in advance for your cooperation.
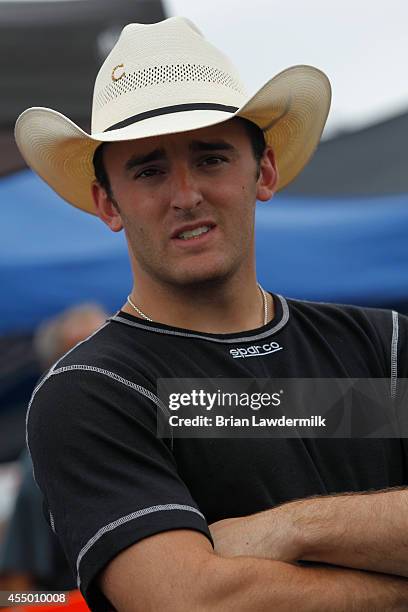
[100,490,408,612]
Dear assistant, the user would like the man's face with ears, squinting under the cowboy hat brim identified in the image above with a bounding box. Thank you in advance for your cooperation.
[94,120,276,286]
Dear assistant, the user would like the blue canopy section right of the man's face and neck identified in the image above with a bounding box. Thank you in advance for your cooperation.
[257,195,408,307]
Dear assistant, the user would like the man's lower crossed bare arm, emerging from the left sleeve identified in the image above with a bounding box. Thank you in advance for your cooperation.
[100,530,408,612]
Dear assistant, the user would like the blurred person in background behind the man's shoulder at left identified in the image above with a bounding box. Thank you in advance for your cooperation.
[0,303,107,591]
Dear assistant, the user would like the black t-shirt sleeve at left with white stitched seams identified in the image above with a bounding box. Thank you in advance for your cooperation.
[27,368,211,610]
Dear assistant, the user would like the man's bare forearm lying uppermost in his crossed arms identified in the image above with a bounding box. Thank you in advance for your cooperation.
[210,489,408,577]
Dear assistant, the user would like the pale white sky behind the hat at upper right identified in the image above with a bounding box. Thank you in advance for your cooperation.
[164,0,408,137]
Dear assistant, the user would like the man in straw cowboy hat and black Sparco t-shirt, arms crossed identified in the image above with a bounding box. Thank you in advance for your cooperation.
[16,18,408,611]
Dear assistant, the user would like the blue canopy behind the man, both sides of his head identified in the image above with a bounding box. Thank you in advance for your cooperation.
[0,170,408,335]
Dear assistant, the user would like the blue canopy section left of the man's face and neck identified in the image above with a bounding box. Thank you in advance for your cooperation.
[0,170,130,334]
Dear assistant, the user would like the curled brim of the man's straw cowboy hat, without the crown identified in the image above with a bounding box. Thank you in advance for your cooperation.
[15,66,331,214]
